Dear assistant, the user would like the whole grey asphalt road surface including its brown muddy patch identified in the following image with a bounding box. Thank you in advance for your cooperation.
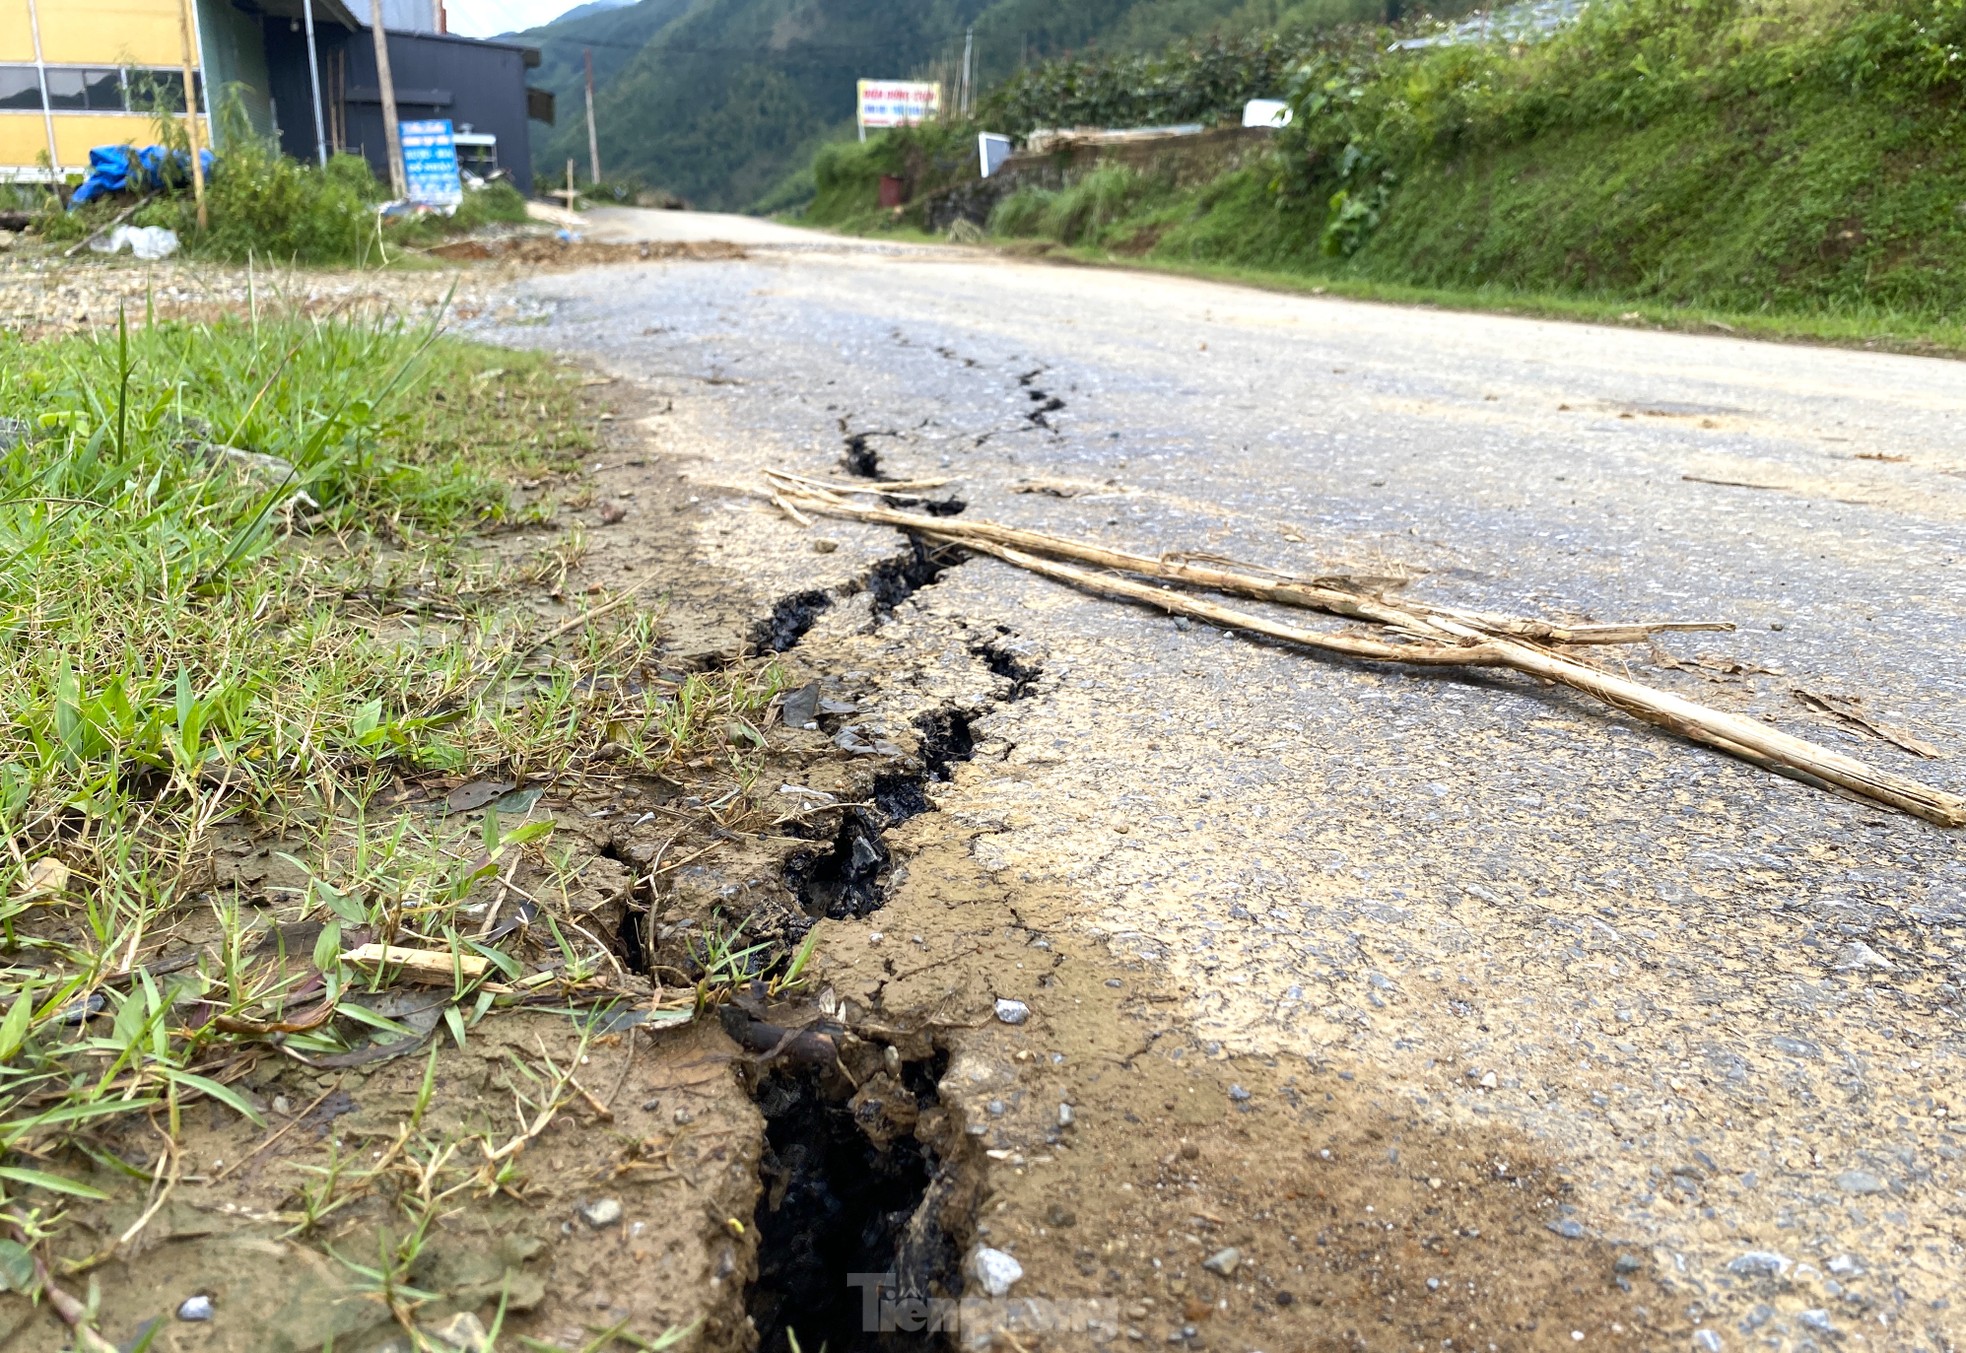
[479,227,1966,1349]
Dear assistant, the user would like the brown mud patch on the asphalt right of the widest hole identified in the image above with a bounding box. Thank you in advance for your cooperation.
[824,829,1691,1353]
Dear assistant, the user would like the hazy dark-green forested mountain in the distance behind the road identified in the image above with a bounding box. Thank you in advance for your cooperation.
[515,0,1415,208]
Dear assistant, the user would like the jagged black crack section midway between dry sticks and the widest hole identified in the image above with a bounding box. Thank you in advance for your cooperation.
[784,706,975,920]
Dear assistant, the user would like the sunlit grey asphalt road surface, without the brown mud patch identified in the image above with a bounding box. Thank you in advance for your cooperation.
[492,216,1966,1349]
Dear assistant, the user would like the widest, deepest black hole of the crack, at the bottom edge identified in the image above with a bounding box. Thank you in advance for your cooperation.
[745,1048,961,1353]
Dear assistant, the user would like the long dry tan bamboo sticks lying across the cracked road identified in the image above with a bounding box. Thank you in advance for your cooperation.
[770,481,1966,826]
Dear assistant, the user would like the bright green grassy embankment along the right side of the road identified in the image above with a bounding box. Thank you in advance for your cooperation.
[814,0,1966,338]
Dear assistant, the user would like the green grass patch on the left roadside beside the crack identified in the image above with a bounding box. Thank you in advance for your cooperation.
[0,306,798,1329]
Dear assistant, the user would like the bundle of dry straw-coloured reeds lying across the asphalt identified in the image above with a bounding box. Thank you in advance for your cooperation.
[767,472,1966,826]
